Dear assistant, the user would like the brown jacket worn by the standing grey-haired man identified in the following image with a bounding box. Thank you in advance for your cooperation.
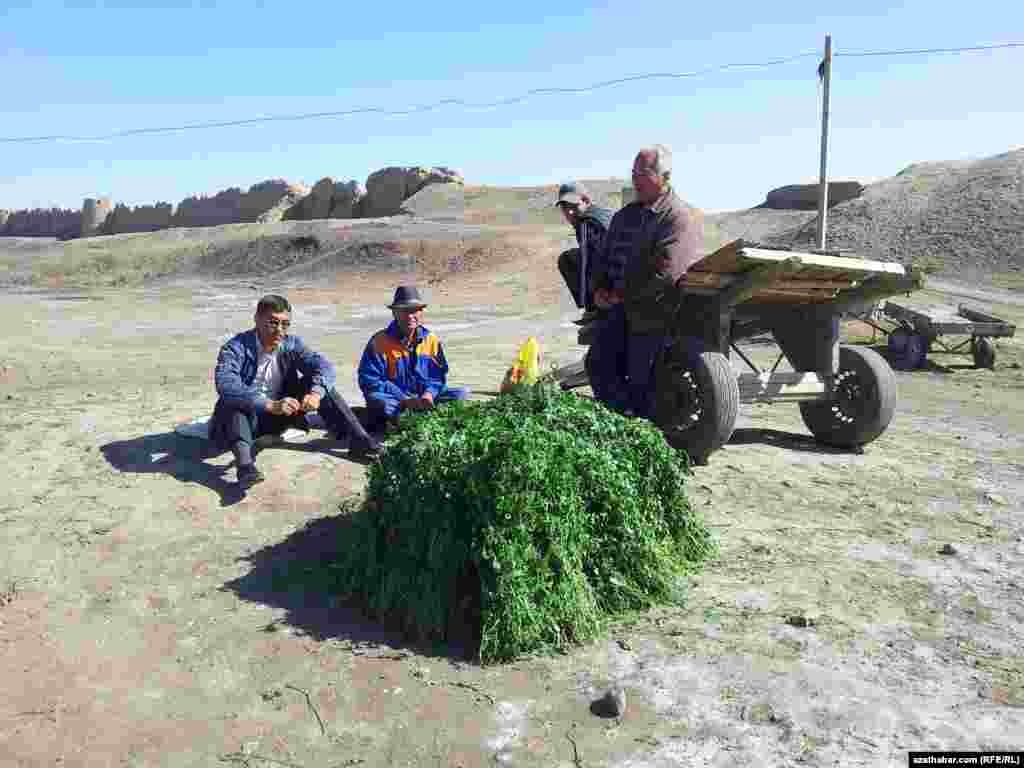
[594,189,703,333]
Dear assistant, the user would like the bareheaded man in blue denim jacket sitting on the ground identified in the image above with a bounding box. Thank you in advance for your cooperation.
[210,294,383,488]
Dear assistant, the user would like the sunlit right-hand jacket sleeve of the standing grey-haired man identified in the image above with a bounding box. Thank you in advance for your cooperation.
[630,204,703,301]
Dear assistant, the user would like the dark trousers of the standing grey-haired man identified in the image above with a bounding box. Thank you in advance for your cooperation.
[587,304,703,419]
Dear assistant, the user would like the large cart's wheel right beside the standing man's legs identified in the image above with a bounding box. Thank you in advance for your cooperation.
[654,352,739,465]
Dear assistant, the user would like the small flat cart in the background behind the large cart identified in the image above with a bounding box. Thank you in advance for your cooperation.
[871,301,1017,371]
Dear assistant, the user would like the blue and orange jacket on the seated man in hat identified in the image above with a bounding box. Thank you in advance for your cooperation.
[358,322,447,400]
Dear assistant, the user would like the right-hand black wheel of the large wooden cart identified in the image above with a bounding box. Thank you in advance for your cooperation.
[800,345,896,447]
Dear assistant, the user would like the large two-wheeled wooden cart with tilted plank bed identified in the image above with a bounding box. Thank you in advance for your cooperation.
[556,241,924,464]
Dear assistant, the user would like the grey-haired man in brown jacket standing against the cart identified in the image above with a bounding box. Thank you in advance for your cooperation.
[588,144,703,418]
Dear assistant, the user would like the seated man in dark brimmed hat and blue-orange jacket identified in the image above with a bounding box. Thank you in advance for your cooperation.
[358,286,469,431]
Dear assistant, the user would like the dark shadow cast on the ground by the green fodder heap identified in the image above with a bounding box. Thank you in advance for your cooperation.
[220,508,479,663]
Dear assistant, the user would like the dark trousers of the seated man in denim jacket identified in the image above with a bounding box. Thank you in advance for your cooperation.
[210,376,370,447]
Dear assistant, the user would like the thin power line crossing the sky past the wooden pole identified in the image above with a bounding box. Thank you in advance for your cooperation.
[0,42,1024,144]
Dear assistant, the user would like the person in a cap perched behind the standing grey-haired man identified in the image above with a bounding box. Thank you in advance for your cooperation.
[555,181,613,326]
